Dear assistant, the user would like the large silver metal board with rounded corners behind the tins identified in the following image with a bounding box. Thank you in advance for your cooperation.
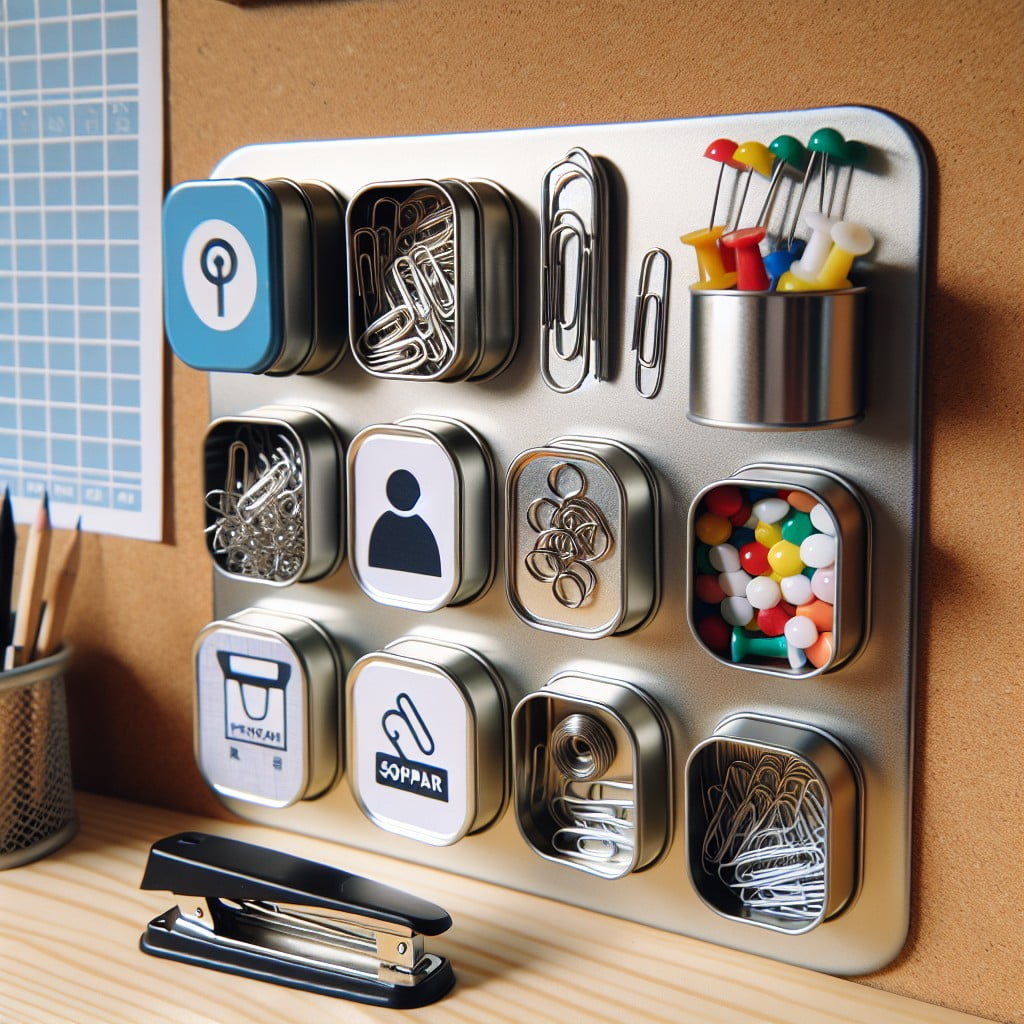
[203,108,927,974]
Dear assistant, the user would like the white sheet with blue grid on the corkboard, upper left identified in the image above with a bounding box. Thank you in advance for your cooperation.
[0,0,163,540]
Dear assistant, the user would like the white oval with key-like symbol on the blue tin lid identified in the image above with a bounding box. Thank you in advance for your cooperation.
[181,219,258,331]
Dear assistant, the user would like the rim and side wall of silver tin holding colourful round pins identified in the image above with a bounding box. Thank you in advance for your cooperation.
[686,463,871,679]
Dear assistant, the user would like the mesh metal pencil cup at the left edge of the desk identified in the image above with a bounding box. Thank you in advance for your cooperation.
[0,646,78,868]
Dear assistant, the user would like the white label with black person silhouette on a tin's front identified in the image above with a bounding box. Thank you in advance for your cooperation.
[351,434,461,610]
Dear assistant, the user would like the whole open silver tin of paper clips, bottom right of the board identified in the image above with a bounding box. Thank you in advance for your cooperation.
[686,714,862,935]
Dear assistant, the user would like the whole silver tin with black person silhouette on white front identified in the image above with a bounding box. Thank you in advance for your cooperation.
[347,416,495,611]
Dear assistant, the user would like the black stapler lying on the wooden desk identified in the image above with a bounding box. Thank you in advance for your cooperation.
[139,833,455,1010]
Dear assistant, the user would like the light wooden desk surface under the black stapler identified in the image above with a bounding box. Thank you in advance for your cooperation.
[0,794,995,1024]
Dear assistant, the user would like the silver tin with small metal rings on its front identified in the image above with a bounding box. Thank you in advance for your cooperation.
[505,436,660,639]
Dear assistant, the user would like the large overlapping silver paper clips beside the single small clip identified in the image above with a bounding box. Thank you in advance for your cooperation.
[541,147,611,394]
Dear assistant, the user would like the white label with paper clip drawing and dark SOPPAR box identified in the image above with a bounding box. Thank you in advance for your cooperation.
[349,658,475,846]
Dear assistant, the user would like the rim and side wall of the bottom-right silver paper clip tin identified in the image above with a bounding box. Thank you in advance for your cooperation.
[683,712,864,935]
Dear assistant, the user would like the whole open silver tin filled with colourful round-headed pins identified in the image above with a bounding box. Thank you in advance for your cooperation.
[686,464,871,679]
